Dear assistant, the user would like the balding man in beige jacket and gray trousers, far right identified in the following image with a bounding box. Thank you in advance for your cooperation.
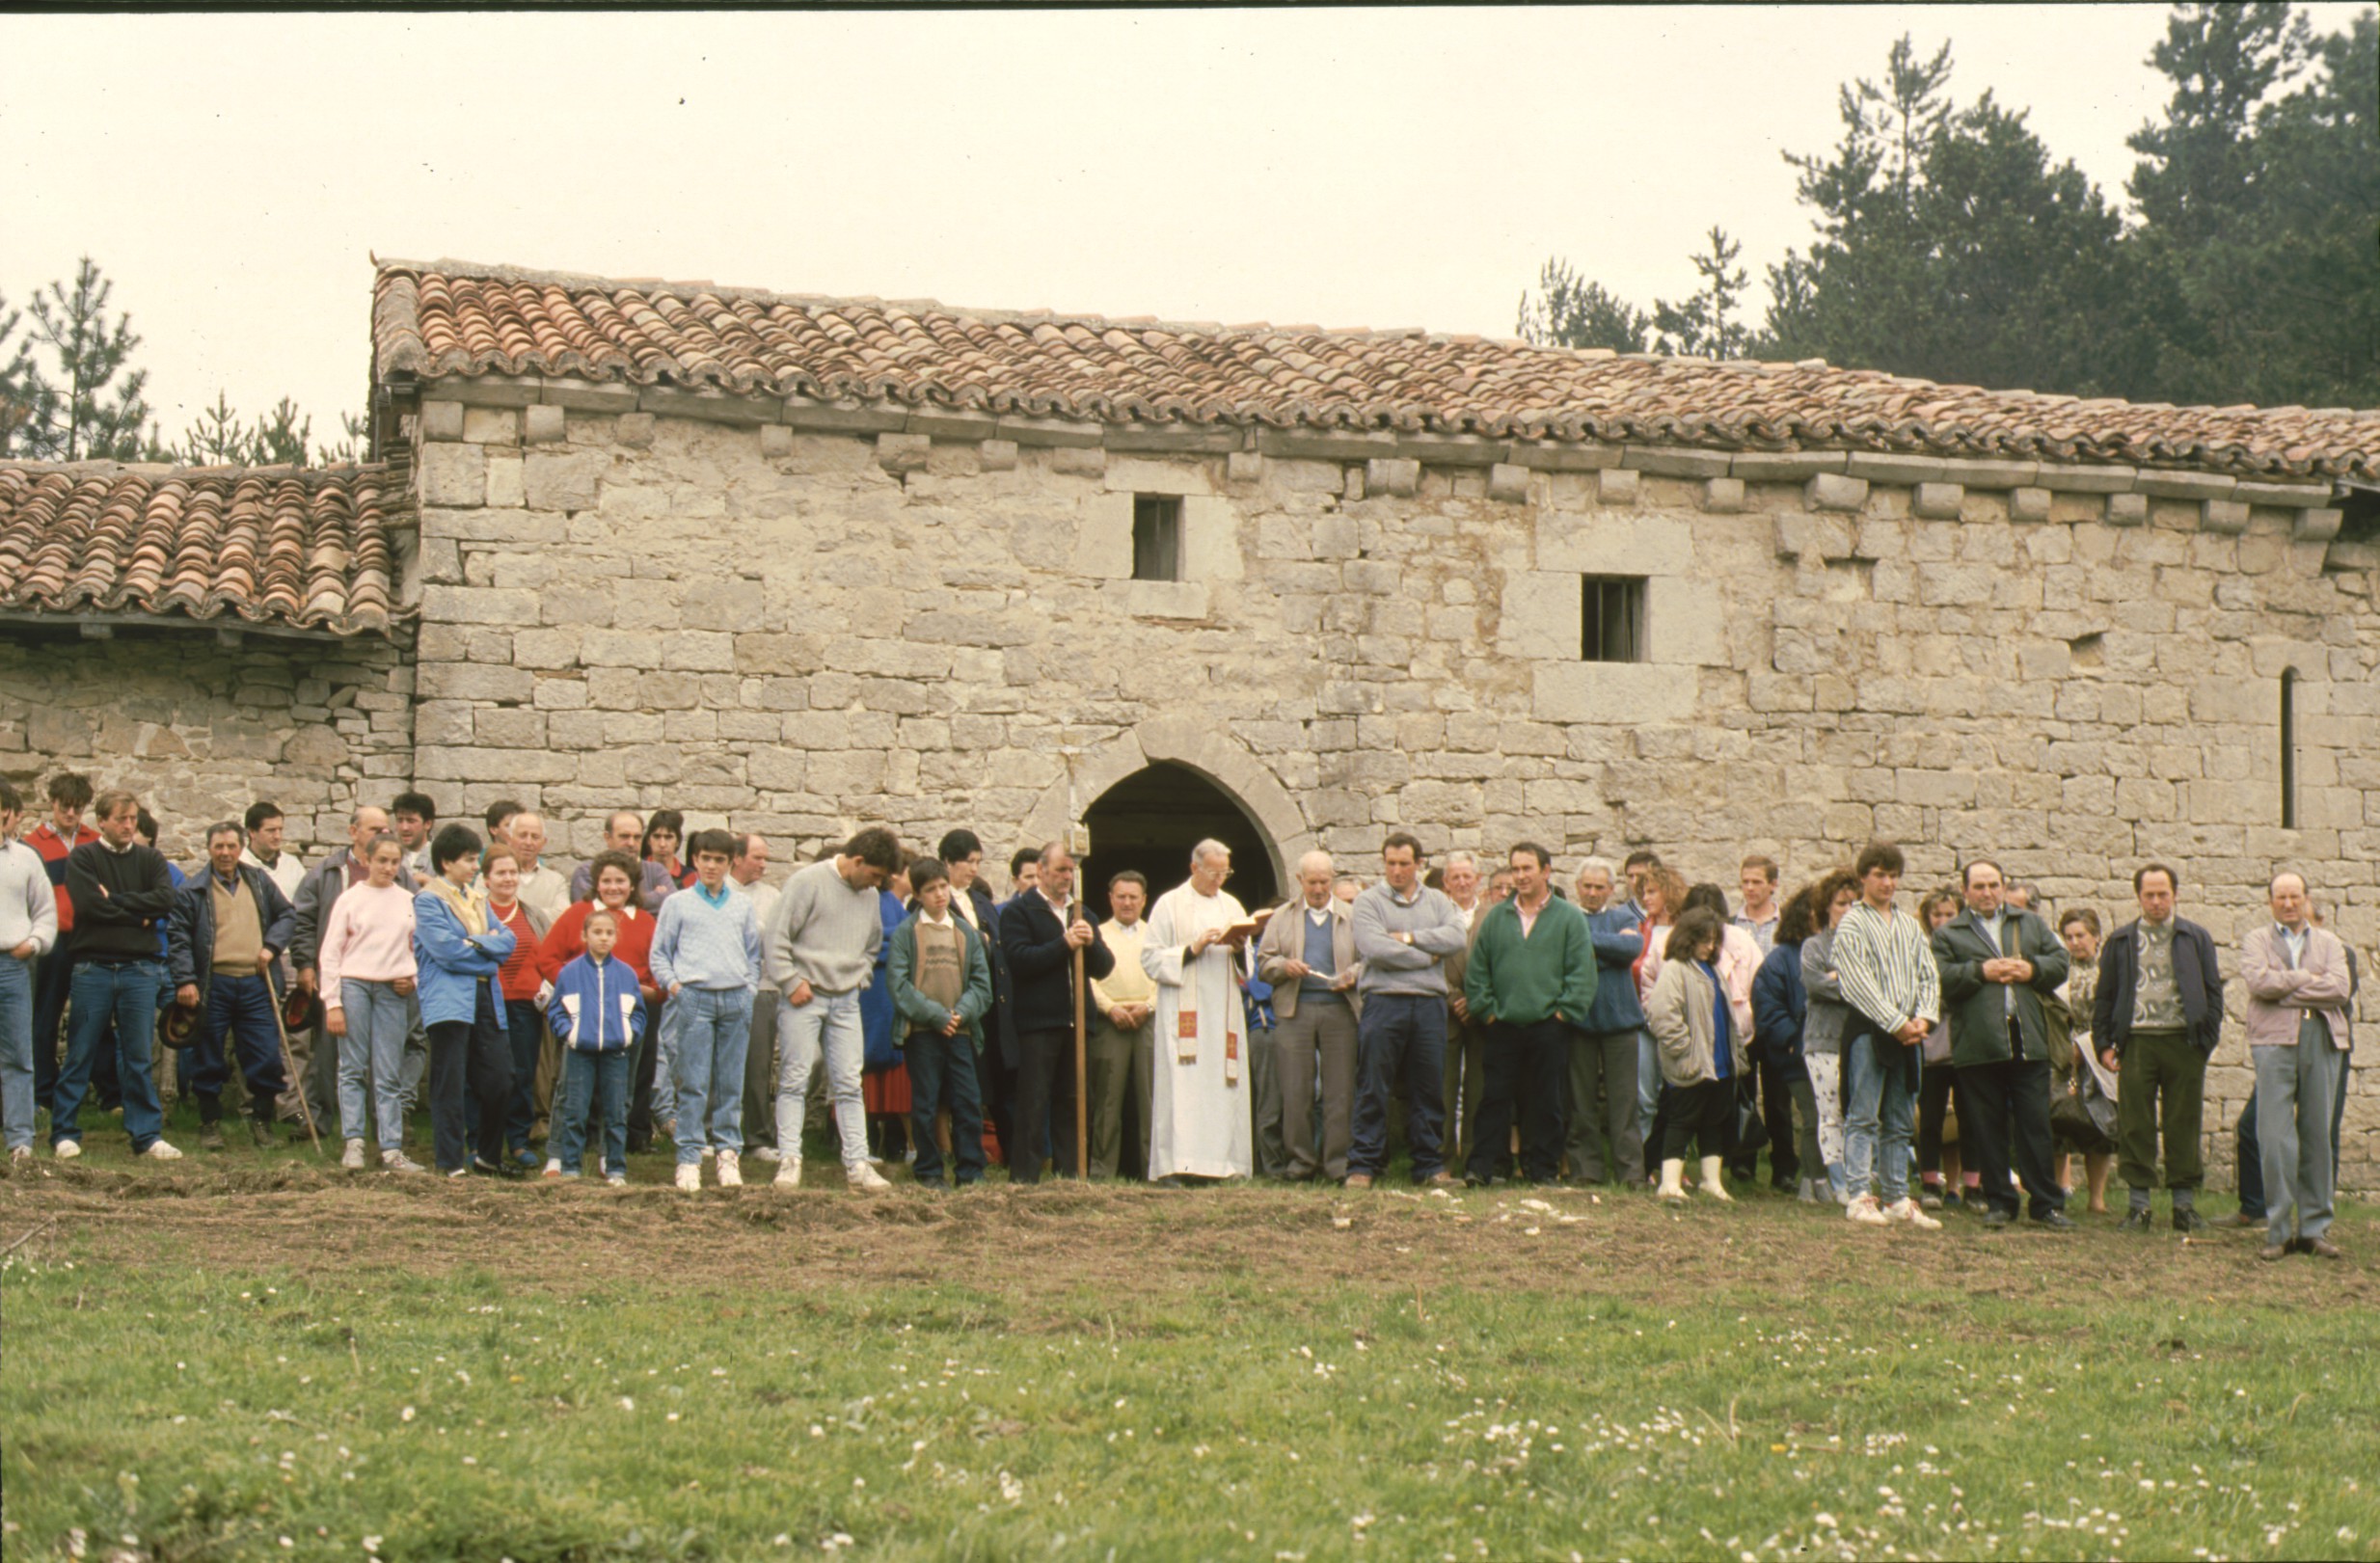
[2239,871,2351,1258]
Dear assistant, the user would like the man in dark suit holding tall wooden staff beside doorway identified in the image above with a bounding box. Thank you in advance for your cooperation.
[1000,842,1116,1182]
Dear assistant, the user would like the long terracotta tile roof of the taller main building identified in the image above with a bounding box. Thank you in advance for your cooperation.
[373,261,2380,478]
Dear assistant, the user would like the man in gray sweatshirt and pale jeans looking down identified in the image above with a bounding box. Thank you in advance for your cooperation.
[762,825,902,1190]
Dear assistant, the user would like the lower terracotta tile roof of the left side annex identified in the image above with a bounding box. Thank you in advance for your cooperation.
[0,462,407,635]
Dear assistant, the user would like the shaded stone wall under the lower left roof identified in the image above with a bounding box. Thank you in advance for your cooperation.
[0,626,414,861]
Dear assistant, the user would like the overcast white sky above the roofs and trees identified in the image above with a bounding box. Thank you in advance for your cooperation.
[0,5,2356,451]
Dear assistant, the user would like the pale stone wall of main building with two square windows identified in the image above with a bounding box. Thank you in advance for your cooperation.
[417,383,2380,1184]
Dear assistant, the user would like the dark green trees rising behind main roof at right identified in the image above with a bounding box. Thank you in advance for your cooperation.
[1519,0,2380,407]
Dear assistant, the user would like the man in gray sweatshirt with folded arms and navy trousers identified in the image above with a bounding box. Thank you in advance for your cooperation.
[1347,830,1466,1190]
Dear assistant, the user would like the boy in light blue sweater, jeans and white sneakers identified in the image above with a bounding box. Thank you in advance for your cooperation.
[652,830,759,1195]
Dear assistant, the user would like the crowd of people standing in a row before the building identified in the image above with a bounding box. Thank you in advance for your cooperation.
[0,773,2359,1258]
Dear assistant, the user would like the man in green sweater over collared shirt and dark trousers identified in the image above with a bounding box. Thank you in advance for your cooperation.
[1464,842,1595,1187]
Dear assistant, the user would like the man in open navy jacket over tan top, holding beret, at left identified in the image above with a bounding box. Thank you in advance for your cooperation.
[167,821,298,1151]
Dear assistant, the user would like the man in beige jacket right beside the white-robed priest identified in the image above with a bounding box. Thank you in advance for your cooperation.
[1257,851,1362,1182]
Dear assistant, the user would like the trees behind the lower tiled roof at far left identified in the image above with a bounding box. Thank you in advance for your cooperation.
[0,255,365,467]
